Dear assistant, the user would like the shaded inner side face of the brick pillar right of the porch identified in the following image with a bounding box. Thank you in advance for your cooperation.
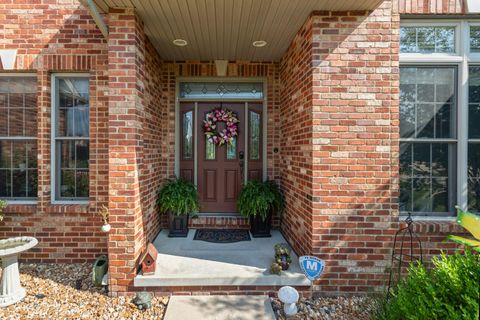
[279,18,314,254]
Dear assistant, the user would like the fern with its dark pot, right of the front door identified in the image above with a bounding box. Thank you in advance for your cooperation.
[237,180,283,238]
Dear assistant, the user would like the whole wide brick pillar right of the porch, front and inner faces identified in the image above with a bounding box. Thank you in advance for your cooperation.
[280,1,399,293]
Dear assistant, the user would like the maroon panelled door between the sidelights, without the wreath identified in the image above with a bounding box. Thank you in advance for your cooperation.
[197,102,245,213]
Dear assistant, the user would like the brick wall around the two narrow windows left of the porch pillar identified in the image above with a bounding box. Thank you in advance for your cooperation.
[0,0,108,262]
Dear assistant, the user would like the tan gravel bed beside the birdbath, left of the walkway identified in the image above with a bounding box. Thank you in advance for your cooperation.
[0,263,168,320]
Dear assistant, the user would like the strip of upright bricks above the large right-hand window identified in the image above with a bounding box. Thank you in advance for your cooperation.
[397,0,466,14]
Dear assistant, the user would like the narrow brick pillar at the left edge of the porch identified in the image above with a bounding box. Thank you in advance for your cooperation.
[108,8,145,295]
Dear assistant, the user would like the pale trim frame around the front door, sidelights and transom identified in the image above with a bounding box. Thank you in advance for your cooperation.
[174,77,268,189]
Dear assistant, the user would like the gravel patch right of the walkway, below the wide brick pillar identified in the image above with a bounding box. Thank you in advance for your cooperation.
[272,297,374,320]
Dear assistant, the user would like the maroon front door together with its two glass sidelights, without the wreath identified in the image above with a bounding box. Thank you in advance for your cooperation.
[180,101,263,213]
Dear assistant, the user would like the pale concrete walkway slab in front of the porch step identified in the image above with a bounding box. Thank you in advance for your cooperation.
[163,296,275,320]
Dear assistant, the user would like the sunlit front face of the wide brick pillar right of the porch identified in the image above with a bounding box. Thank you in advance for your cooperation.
[312,1,399,293]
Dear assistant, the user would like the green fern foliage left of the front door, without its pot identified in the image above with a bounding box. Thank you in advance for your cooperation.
[157,178,200,216]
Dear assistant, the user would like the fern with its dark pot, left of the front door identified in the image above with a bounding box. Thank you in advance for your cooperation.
[157,178,200,237]
